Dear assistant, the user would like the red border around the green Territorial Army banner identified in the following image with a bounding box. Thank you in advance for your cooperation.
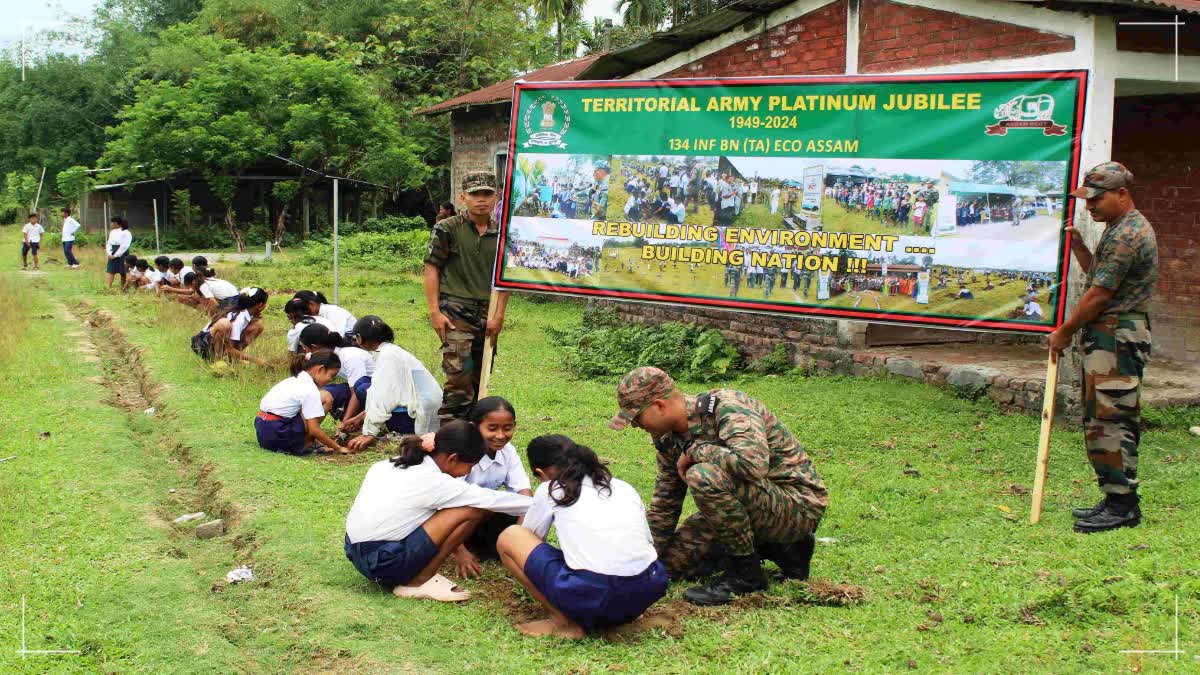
[492,70,1088,334]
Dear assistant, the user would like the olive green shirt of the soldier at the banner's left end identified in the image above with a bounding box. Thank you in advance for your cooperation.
[425,215,499,300]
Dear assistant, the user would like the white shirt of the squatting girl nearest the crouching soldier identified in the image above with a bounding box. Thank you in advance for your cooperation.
[523,478,659,577]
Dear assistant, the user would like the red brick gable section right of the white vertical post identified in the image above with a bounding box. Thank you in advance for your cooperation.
[858,0,1075,73]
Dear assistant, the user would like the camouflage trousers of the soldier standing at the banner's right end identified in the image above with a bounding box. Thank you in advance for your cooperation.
[1081,313,1150,495]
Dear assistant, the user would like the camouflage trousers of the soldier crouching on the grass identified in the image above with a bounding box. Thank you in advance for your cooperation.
[659,464,822,579]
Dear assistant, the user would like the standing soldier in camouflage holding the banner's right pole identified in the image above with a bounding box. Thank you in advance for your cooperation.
[1050,162,1158,532]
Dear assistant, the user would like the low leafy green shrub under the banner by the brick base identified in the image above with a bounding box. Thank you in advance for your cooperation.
[550,307,740,380]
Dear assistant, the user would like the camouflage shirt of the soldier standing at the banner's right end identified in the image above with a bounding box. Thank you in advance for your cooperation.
[1087,209,1158,313]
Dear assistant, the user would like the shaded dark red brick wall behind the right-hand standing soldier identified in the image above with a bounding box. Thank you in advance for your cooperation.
[1112,95,1200,362]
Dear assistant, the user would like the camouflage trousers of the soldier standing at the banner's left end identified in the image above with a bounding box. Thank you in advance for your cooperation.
[438,295,487,422]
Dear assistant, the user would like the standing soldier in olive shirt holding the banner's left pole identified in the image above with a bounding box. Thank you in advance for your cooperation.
[425,171,509,422]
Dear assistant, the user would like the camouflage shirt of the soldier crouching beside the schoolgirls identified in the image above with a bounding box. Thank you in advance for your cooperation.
[646,389,829,552]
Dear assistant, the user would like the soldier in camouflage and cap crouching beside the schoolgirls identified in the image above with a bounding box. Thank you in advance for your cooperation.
[611,368,829,605]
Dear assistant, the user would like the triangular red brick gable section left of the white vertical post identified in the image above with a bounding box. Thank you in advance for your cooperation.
[662,0,846,78]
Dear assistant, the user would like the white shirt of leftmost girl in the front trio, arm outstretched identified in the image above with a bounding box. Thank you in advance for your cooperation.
[346,456,532,544]
